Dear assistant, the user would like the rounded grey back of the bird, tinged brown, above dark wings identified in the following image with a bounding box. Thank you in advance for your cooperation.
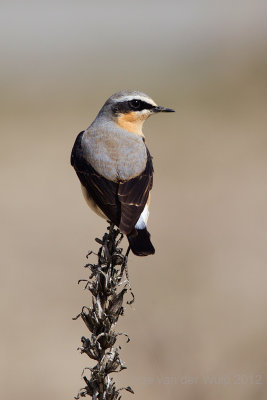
[82,128,147,181]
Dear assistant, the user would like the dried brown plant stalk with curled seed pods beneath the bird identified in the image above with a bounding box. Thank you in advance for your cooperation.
[73,224,134,400]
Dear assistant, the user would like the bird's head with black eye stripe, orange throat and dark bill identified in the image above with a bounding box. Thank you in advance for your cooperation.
[101,90,174,136]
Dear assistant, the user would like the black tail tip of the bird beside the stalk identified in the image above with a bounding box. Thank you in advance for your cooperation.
[127,228,155,256]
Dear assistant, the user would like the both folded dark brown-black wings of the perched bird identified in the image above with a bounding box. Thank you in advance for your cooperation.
[71,132,153,234]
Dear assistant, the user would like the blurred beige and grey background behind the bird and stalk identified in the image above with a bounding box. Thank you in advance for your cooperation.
[0,0,267,400]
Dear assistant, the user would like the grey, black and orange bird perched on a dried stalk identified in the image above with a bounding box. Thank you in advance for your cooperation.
[71,90,174,256]
